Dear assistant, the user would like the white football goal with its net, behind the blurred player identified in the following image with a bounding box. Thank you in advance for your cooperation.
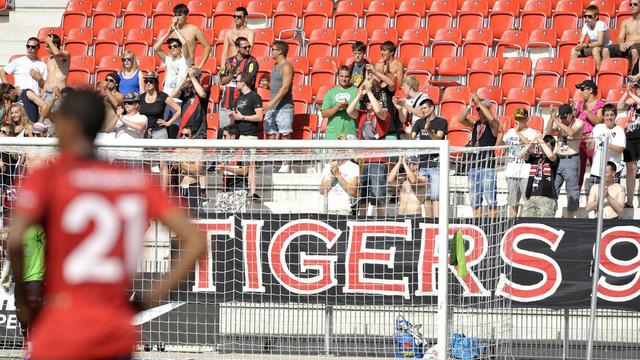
[0,139,513,359]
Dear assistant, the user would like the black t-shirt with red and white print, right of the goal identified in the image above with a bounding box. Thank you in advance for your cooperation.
[525,151,560,199]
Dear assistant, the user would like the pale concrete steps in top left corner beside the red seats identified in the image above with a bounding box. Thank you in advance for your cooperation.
[0,0,67,66]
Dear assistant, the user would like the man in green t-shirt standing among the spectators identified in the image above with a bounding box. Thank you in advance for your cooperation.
[322,65,358,140]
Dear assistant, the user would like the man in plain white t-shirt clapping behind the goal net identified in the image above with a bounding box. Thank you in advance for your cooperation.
[320,134,360,215]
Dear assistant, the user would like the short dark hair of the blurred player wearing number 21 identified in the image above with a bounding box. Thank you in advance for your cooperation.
[55,90,106,141]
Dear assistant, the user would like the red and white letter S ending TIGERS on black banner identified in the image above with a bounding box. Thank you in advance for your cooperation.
[496,224,564,302]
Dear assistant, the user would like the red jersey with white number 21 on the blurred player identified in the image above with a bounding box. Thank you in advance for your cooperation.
[15,153,172,360]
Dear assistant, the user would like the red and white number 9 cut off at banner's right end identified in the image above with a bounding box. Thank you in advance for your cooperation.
[594,226,640,302]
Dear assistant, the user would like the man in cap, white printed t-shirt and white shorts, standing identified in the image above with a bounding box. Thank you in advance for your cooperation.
[502,108,540,217]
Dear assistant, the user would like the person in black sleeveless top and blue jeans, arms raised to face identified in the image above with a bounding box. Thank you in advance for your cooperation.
[457,94,500,218]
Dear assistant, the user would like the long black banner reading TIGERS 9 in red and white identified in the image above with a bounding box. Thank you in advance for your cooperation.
[182,214,640,310]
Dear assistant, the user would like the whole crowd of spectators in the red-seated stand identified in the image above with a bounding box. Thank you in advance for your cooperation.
[0,0,640,218]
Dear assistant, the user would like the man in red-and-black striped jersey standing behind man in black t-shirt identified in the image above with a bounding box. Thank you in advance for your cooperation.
[218,36,258,128]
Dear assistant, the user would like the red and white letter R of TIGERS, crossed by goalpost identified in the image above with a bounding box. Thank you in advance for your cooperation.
[415,223,491,297]
